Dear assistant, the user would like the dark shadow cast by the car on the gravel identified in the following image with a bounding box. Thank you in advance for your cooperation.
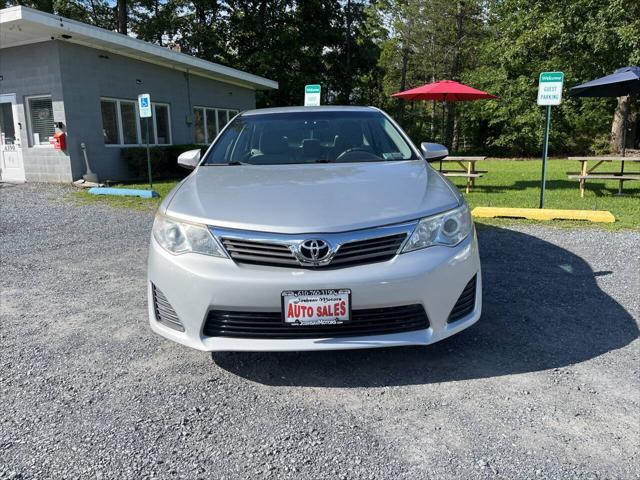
[212,226,638,388]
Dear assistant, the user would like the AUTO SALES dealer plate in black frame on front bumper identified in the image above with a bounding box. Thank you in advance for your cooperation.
[281,288,353,327]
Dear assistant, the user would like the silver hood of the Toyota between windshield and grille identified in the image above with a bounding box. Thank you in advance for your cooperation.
[163,160,461,233]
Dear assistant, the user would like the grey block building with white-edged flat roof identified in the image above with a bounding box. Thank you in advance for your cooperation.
[0,7,278,182]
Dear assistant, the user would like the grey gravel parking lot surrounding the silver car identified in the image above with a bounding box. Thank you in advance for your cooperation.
[0,185,640,479]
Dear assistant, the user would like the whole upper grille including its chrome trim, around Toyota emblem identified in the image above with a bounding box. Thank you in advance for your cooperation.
[210,221,418,268]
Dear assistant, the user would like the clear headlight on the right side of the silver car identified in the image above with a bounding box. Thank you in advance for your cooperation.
[402,205,473,252]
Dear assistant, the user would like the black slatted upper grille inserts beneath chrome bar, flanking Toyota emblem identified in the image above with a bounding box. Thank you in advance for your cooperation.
[221,233,407,268]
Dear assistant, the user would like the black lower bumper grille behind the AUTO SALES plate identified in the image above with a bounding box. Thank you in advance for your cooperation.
[203,305,429,339]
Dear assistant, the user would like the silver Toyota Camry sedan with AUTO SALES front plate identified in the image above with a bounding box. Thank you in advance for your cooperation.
[148,107,482,351]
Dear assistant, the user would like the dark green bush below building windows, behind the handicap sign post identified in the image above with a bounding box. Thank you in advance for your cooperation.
[120,144,206,178]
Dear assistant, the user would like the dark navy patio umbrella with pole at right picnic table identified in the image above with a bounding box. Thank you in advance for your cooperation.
[569,67,640,155]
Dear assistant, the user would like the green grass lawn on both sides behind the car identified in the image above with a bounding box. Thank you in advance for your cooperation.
[72,160,640,230]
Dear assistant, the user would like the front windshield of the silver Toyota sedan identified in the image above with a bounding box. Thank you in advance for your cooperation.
[204,110,417,165]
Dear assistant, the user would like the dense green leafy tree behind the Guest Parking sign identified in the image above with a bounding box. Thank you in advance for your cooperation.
[463,0,640,155]
